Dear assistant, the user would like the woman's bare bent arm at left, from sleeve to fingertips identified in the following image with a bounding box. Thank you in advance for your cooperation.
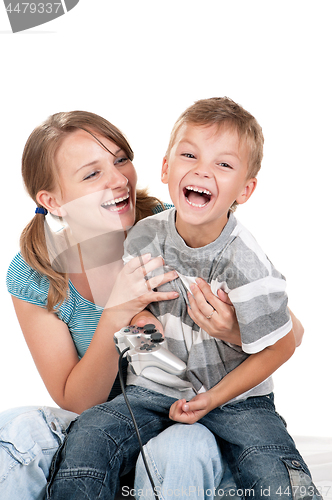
[13,254,178,413]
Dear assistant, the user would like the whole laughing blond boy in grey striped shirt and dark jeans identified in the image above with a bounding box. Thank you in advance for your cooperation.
[48,99,319,500]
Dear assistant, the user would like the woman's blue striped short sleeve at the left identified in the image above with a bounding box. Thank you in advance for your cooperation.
[6,252,50,307]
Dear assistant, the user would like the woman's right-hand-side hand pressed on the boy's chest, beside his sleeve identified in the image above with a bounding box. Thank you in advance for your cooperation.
[188,278,241,346]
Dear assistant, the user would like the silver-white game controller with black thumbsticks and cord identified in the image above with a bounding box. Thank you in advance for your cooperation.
[114,324,186,375]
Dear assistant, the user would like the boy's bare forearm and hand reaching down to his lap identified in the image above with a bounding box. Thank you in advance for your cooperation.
[169,330,295,424]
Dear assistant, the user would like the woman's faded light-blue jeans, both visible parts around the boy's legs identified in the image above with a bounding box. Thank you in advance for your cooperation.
[0,406,232,500]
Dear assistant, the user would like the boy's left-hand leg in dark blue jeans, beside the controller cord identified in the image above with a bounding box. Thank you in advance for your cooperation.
[47,386,174,500]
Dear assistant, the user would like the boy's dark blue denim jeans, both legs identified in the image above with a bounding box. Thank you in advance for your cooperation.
[47,386,319,500]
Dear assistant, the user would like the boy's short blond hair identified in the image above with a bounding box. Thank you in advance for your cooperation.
[166,97,264,179]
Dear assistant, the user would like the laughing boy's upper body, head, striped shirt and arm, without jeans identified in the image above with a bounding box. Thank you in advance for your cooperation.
[125,99,295,423]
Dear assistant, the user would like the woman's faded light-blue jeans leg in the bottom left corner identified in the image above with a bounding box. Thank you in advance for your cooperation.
[0,406,77,500]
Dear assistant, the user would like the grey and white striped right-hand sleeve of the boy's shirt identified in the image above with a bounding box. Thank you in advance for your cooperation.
[222,226,292,354]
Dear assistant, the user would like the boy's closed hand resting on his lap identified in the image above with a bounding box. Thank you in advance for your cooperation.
[169,392,213,424]
